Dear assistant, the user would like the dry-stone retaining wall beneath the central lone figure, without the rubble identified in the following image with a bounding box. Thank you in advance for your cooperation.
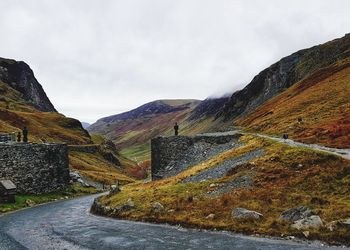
[151,134,241,180]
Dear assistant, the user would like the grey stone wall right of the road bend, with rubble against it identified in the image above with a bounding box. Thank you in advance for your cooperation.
[151,134,241,180]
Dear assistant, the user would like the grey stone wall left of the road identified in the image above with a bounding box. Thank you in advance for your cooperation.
[0,142,69,194]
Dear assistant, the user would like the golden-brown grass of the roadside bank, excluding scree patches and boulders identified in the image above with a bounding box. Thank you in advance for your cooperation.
[98,136,350,243]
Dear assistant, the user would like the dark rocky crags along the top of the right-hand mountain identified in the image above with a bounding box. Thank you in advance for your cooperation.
[216,34,350,120]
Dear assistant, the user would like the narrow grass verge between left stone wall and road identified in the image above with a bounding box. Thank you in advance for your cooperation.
[0,184,97,214]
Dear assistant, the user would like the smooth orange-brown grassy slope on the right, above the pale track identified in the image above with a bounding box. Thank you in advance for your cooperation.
[236,59,350,148]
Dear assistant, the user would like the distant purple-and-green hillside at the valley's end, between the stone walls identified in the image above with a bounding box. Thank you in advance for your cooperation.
[88,100,199,161]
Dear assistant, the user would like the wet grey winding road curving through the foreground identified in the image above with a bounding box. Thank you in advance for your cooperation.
[0,195,344,250]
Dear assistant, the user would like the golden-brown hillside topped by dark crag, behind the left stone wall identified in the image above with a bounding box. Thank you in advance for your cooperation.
[0,58,133,183]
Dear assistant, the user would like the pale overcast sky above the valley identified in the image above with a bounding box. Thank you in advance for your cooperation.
[0,0,350,123]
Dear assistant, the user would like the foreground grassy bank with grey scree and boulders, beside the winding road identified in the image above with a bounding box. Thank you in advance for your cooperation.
[92,135,350,244]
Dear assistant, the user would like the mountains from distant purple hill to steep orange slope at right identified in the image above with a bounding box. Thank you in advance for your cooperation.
[89,34,350,159]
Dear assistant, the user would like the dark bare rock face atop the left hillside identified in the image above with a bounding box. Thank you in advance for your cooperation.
[0,58,56,112]
